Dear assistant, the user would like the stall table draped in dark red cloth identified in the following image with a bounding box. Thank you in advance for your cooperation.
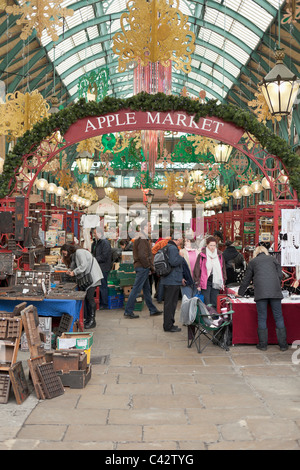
[232,298,300,345]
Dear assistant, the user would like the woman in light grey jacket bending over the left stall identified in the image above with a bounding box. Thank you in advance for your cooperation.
[60,244,103,329]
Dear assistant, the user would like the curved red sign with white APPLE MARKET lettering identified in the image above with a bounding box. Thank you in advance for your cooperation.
[64,109,244,145]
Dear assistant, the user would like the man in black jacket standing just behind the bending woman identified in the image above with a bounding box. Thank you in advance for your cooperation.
[91,227,112,310]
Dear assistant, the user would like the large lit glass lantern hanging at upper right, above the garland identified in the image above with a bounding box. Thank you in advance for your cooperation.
[260,49,299,116]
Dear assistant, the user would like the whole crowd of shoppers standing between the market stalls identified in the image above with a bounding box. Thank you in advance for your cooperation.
[61,221,288,351]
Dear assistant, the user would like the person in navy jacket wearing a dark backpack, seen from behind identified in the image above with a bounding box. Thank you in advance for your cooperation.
[160,238,183,333]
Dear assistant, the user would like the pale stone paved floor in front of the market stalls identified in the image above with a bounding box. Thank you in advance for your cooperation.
[0,302,300,451]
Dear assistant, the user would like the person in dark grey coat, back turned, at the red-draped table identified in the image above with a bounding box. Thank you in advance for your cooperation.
[238,246,288,351]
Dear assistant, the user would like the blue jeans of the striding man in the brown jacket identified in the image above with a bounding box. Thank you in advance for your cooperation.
[124,268,157,315]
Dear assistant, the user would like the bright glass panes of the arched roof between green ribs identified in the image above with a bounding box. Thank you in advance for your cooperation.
[32,0,285,102]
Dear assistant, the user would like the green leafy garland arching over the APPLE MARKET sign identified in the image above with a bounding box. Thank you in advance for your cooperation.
[0,92,300,198]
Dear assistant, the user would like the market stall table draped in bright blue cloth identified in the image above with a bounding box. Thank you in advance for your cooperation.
[0,293,85,331]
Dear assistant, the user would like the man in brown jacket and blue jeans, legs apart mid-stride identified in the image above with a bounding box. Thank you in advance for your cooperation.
[124,221,162,318]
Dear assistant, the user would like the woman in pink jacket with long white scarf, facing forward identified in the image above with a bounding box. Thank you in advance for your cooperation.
[194,237,226,307]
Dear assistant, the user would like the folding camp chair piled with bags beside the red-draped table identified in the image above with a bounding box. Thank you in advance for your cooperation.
[187,295,234,353]
